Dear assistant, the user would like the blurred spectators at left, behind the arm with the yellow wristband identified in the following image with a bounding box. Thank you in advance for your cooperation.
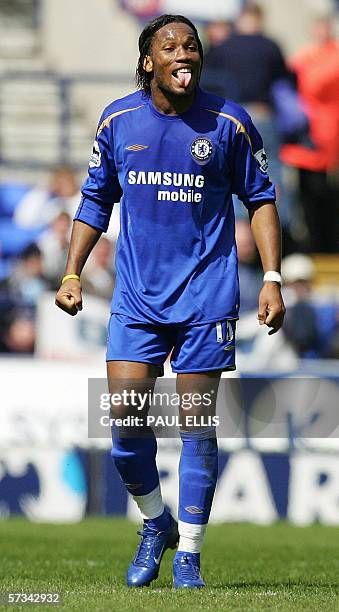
[0,167,114,354]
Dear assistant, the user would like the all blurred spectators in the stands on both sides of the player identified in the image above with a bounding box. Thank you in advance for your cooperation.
[0,3,339,358]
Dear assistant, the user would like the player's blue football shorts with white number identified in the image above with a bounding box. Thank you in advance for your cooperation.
[106,314,236,376]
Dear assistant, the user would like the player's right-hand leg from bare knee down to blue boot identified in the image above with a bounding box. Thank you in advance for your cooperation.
[173,371,221,588]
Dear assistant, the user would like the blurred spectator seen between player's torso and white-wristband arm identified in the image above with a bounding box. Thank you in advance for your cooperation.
[235,219,262,313]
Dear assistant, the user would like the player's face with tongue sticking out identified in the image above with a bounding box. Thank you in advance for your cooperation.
[144,23,201,96]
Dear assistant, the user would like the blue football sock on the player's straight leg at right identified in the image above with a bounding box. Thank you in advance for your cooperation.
[179,427,218,525]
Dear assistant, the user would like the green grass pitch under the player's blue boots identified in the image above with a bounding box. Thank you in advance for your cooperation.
[0,518,339,612]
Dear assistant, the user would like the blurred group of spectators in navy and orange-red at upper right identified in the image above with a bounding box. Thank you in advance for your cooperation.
[202,3,339,253]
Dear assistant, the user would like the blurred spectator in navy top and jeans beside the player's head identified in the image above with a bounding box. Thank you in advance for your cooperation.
[202,3,288,224]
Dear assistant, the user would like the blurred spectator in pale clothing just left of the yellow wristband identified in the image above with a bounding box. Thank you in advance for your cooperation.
[38,212,71,290]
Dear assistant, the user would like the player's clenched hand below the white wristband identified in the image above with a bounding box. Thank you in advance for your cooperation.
[258,282,285,336]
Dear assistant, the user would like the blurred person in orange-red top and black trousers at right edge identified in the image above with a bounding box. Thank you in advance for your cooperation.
[282,17,339,253]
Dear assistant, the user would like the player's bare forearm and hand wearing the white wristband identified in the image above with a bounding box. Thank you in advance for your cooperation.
[249,202,285,335]
